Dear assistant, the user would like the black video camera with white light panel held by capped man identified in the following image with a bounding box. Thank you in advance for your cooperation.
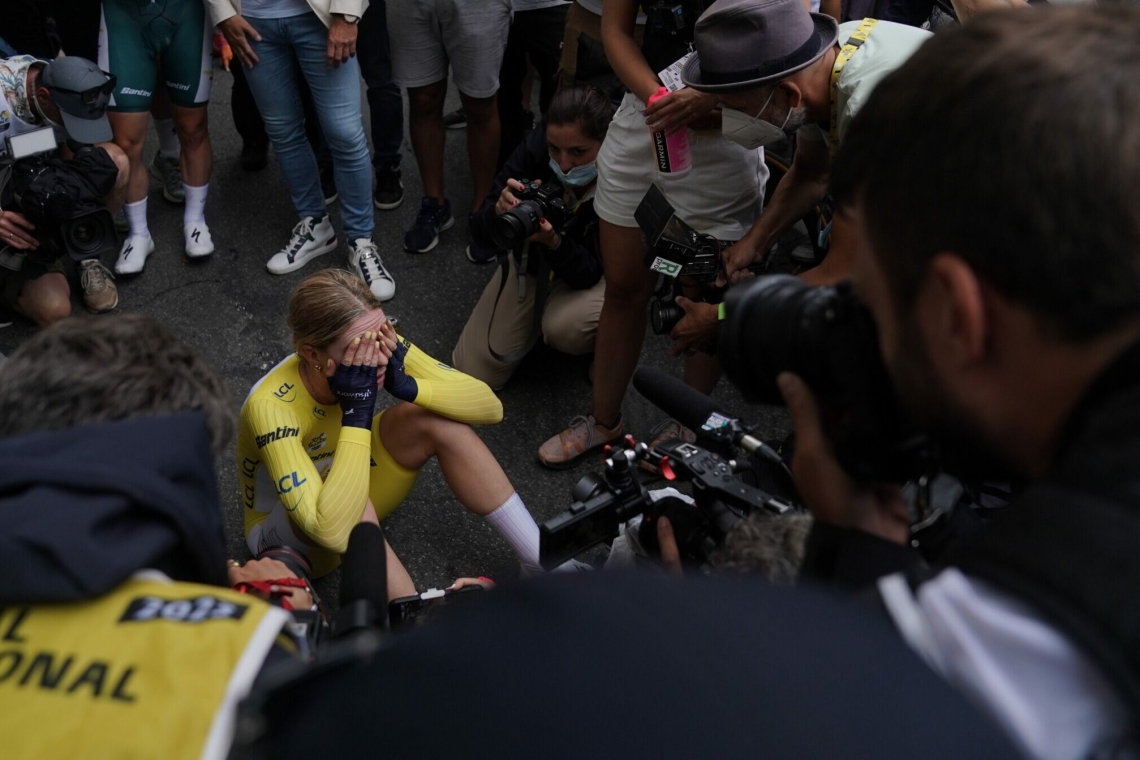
[3,126,119,263]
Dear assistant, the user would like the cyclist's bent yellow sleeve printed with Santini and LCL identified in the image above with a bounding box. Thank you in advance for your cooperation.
[243,398,372,554]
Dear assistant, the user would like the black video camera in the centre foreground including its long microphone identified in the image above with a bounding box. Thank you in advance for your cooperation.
[539,367,796,569]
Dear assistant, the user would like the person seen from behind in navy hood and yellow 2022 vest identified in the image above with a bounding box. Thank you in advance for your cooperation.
[0,314,304,759]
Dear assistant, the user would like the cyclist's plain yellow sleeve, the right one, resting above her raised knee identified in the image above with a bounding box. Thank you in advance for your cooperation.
[400,338,503,425]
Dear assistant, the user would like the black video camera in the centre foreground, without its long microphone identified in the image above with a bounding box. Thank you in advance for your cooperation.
[539,435,795,570]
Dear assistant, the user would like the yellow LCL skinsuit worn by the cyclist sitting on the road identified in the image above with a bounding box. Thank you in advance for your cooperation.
[237,337,503,575]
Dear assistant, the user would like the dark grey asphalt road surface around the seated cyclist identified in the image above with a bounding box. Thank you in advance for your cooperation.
[0,67,787,599]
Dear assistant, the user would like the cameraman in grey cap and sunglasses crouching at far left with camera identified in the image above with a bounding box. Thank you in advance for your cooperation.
[0,56,129,325]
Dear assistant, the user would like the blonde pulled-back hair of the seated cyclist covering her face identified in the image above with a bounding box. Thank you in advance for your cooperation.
[288,269,381,353]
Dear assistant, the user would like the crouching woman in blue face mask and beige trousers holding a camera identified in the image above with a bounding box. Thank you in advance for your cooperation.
[451,85,613,391]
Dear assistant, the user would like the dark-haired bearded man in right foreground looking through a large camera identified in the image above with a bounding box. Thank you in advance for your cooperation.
[720,8,1140,758]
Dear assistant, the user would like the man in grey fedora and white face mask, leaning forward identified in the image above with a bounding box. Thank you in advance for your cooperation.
[682,0,931,289]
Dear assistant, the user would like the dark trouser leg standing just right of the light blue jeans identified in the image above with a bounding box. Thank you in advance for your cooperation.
[357,0,404,170]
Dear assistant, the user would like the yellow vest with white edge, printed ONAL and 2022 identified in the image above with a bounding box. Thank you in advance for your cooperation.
[0,571,290,760]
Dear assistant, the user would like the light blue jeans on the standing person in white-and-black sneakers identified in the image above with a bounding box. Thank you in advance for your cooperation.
[245,13,373,240]
